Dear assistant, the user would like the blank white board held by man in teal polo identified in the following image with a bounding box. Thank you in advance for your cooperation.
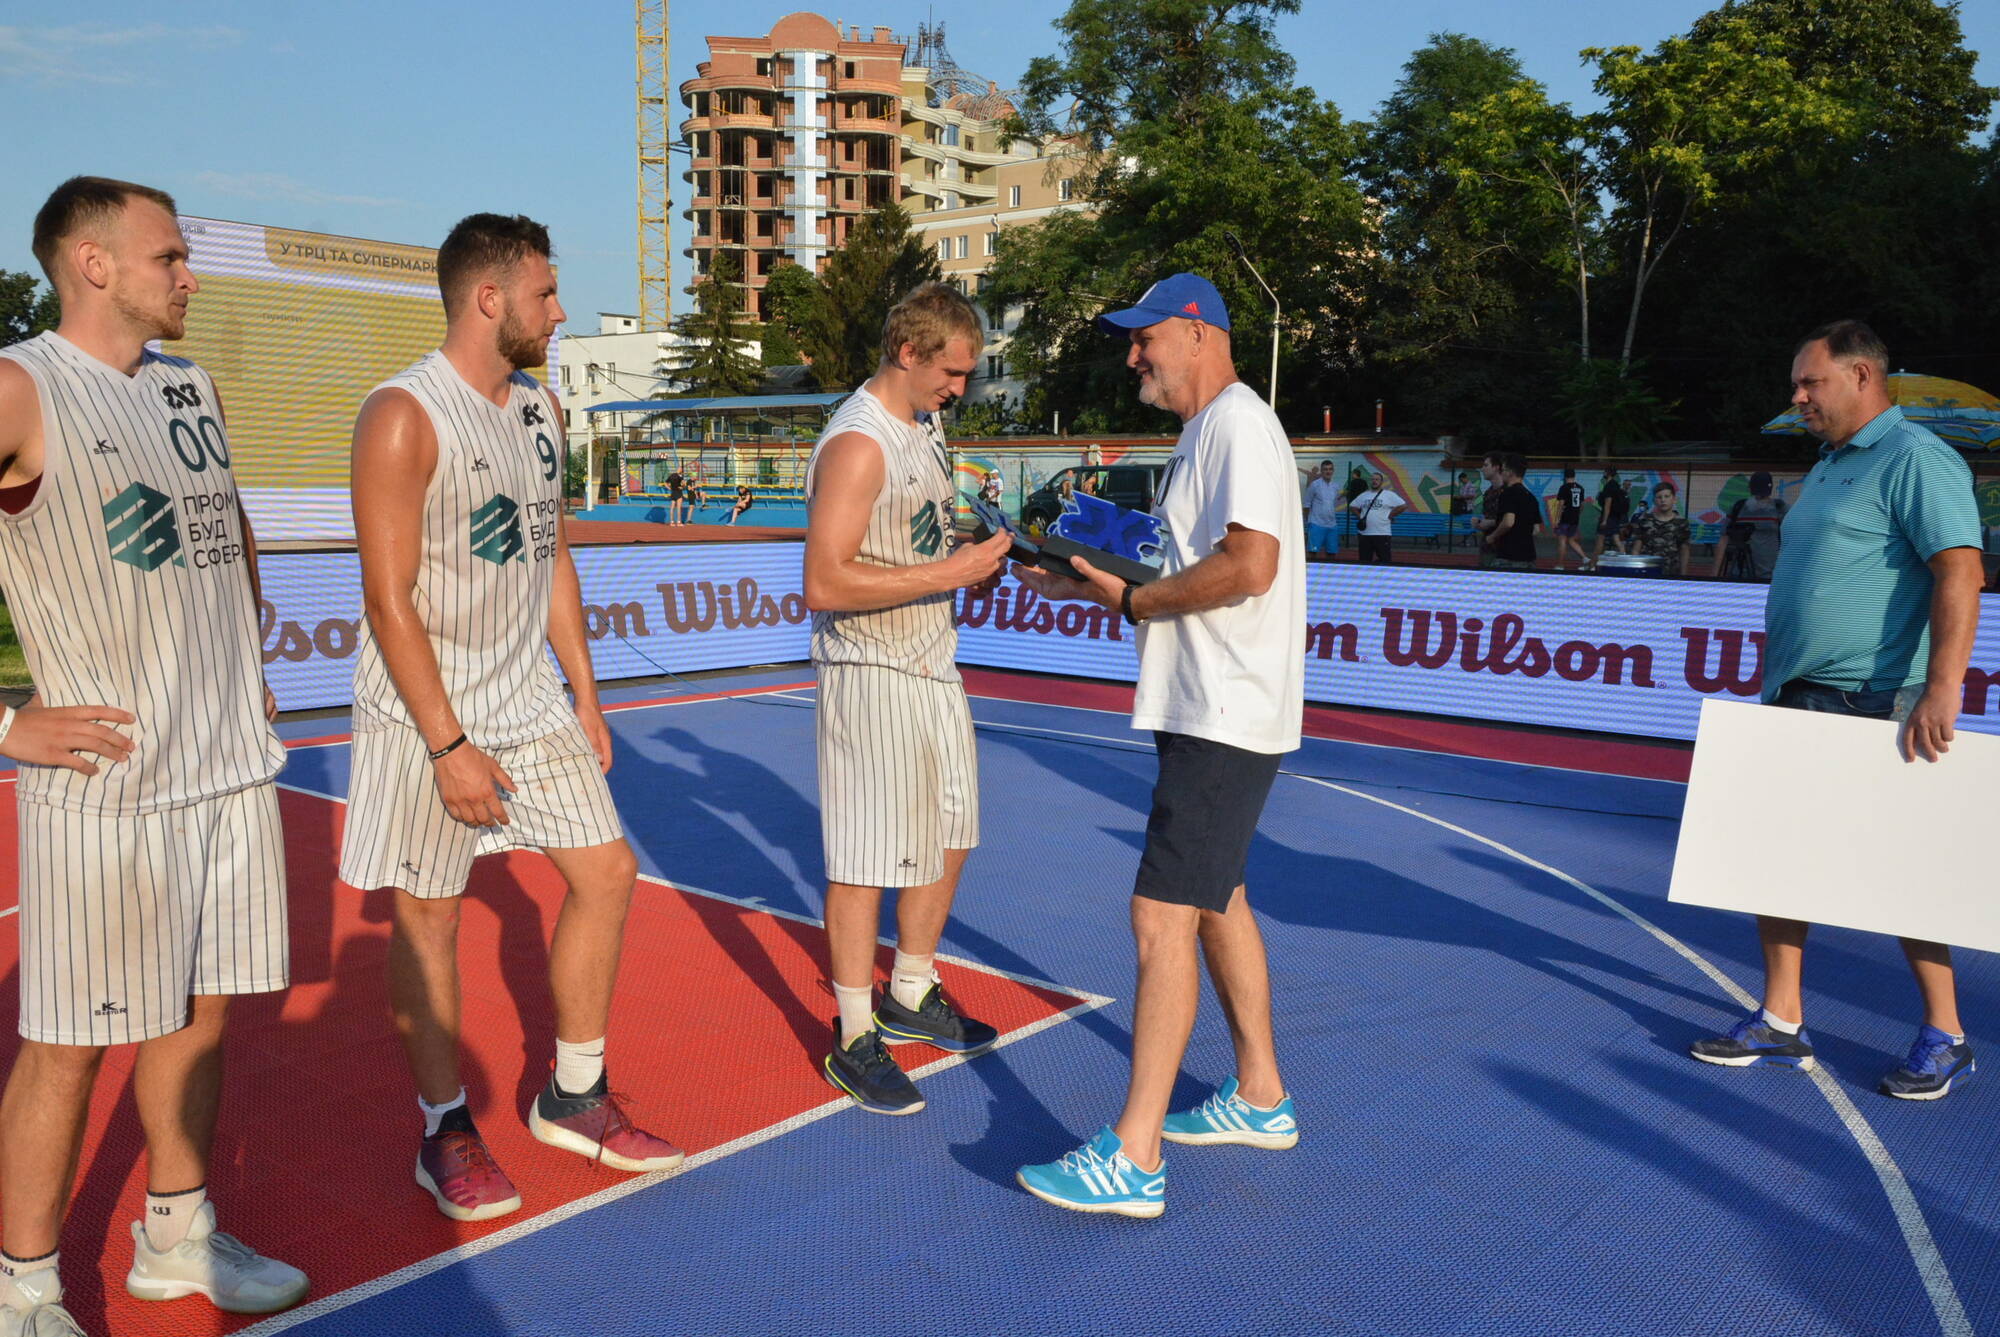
[1668,701,2000,951]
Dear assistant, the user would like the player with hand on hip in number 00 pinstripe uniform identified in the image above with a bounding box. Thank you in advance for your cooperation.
[0,176,306,1337]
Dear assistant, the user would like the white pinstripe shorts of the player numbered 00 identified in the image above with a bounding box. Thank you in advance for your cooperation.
[20,783,292,1045]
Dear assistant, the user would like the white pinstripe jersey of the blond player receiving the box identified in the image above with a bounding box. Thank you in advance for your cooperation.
[806,386,958,683]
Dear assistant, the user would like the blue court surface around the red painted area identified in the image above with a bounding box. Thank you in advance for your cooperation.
[246,669,2000,1337]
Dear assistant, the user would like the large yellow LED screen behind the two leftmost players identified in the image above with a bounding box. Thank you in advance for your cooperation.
[168,216,556,540]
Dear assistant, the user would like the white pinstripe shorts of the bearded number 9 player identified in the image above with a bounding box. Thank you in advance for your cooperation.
[340,719,624,901]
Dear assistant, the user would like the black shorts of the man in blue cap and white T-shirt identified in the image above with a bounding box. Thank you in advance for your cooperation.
[1132,733,1282,913]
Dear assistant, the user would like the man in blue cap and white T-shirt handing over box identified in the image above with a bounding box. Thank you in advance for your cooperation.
[1014,274,1306,1217]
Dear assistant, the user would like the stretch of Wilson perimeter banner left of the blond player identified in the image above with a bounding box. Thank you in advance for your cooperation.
[258,542,812,711]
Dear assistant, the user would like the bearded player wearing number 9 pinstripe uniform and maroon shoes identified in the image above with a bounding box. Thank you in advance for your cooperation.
[340,214,682,1221]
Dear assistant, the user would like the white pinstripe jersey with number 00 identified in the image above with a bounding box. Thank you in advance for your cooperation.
[0,334,284,815]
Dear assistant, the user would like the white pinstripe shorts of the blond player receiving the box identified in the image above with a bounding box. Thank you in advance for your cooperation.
[816,664,980,887]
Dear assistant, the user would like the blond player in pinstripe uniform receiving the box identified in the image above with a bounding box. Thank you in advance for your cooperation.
[806,282,1010,1115]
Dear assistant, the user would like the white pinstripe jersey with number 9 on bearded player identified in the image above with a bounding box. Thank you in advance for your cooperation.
[354,352,570,749]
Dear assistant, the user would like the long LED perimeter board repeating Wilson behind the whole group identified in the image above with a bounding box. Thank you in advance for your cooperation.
[262,542,2000,739]
